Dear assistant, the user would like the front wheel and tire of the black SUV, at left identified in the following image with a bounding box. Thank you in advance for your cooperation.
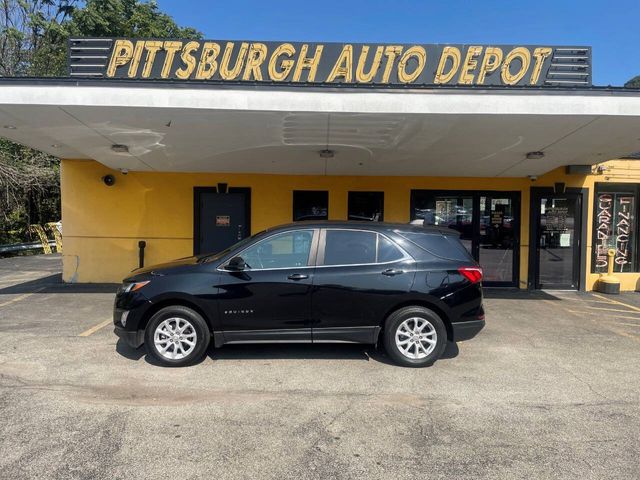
[144,305,211,367]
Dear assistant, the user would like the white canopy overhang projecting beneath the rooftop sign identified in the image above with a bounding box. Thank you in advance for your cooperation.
[0,80,640,177]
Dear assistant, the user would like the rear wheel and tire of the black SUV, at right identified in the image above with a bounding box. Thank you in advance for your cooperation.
[383,306,447,368]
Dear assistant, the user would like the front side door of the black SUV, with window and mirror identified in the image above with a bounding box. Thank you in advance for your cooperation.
[217,229,319,343]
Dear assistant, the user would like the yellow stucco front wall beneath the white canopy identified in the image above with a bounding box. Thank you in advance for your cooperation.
[61,160,640,290]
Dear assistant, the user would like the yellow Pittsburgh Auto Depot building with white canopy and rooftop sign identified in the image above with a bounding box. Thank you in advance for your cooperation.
[0,38,640,291]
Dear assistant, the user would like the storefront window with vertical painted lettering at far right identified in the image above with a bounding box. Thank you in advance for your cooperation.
[591,183,639,273]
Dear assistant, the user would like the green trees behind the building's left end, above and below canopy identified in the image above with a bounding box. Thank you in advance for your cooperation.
[0,0,202,244]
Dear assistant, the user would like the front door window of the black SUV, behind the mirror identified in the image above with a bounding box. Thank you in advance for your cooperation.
[240,230,313,270]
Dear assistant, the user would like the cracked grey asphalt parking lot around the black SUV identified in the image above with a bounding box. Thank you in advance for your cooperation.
[0,255,640,479]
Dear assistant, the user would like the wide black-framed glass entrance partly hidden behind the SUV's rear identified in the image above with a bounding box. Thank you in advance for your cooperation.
[411,190,520,287]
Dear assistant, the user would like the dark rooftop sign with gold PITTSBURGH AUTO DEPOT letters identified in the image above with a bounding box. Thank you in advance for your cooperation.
[69,38,591,87]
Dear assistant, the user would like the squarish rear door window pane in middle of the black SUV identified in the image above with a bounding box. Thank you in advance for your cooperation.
[324,230,377,265]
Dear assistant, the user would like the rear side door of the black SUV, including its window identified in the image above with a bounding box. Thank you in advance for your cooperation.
[311,228,415,343]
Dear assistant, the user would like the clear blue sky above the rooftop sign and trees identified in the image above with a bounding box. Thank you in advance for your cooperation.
[158,0,640,85]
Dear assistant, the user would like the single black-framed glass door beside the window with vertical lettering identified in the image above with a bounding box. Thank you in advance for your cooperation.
[536,194,581,289]
